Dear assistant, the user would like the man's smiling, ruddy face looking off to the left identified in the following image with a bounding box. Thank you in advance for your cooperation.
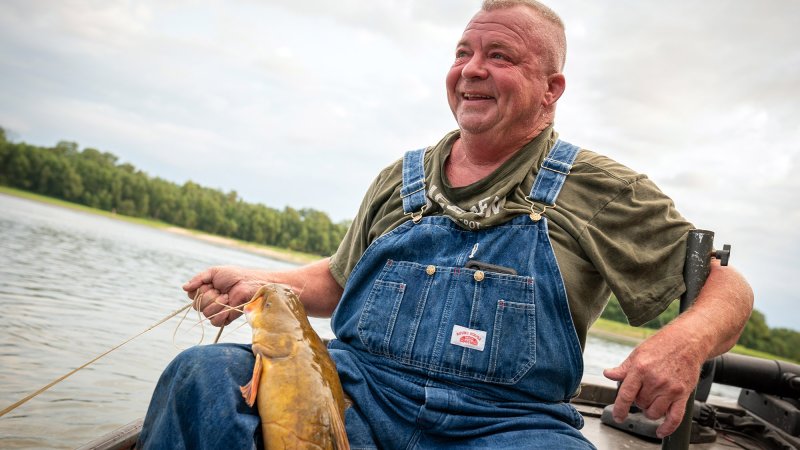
[446,6,552,137]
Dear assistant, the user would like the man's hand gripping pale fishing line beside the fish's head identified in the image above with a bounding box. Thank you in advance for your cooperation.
[183,266,269,327]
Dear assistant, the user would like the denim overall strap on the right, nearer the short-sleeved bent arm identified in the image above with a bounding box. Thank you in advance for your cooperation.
[528,139,580,220]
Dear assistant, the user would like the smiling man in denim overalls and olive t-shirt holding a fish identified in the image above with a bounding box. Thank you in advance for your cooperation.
[136,0,752,449]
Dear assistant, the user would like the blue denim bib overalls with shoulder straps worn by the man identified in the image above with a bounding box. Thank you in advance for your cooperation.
[138,141,594,449]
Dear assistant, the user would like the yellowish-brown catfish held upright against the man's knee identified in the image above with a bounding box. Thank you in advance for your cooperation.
[241,284,350,450]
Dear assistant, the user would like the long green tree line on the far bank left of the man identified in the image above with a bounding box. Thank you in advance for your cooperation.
[0,128,349,255]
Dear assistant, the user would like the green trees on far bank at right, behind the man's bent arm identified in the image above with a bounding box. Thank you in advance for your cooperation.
[601,295,800,361]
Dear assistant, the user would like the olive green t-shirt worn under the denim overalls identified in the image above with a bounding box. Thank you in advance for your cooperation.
[330,127,692,346]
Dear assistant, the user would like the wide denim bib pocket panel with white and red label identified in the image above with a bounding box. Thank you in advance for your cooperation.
[358,260,536,384]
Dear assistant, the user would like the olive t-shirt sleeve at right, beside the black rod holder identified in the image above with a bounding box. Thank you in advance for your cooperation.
[580,175,692,326]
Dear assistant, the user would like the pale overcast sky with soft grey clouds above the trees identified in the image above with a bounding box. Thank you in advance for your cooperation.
[0,0,800,330]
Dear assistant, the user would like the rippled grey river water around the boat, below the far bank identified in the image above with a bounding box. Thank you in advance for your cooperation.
[0,194,736,449]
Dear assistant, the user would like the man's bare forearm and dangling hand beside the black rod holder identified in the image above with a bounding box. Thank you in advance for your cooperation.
[603,260,753,438]
